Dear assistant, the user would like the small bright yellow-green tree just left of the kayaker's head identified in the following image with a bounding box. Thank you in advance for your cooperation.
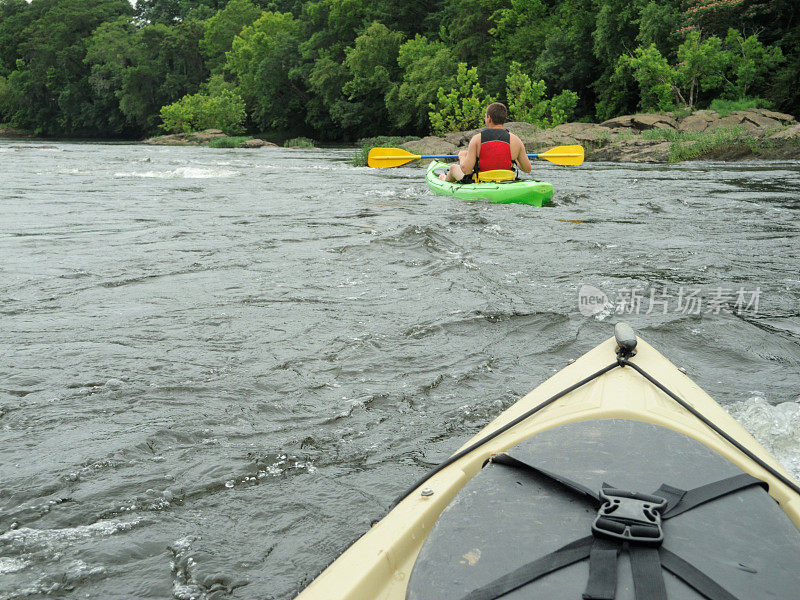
[428,63,495,135]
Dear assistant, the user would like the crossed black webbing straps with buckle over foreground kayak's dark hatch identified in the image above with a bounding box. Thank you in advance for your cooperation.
[462,454,769,600]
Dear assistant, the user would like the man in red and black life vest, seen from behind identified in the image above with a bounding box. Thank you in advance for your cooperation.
[439,102,531,183]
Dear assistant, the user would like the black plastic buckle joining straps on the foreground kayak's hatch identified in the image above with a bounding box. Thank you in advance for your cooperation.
[592,488,667,546]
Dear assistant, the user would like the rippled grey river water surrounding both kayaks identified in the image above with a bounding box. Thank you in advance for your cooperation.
[0,141,800,600]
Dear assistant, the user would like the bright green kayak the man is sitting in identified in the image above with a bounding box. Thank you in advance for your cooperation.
[425,160,553,206]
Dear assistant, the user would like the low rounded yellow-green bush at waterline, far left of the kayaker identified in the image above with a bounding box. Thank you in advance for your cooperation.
[156,90,246,134]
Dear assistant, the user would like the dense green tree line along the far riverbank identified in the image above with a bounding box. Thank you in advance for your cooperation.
[0,0,800,141]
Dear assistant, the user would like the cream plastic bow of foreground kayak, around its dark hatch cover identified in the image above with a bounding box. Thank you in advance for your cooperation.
[299,338,800,600]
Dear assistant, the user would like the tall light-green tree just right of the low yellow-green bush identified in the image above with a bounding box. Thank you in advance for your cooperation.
[225,12,307,128]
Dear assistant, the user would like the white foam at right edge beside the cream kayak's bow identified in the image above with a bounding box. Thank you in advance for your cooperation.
[725,395,800,479]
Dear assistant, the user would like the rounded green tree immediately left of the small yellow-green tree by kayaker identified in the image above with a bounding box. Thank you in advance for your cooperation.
[386,34,456,135]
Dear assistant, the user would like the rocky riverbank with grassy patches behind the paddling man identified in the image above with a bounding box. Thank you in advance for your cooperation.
[403,109,800,163]
